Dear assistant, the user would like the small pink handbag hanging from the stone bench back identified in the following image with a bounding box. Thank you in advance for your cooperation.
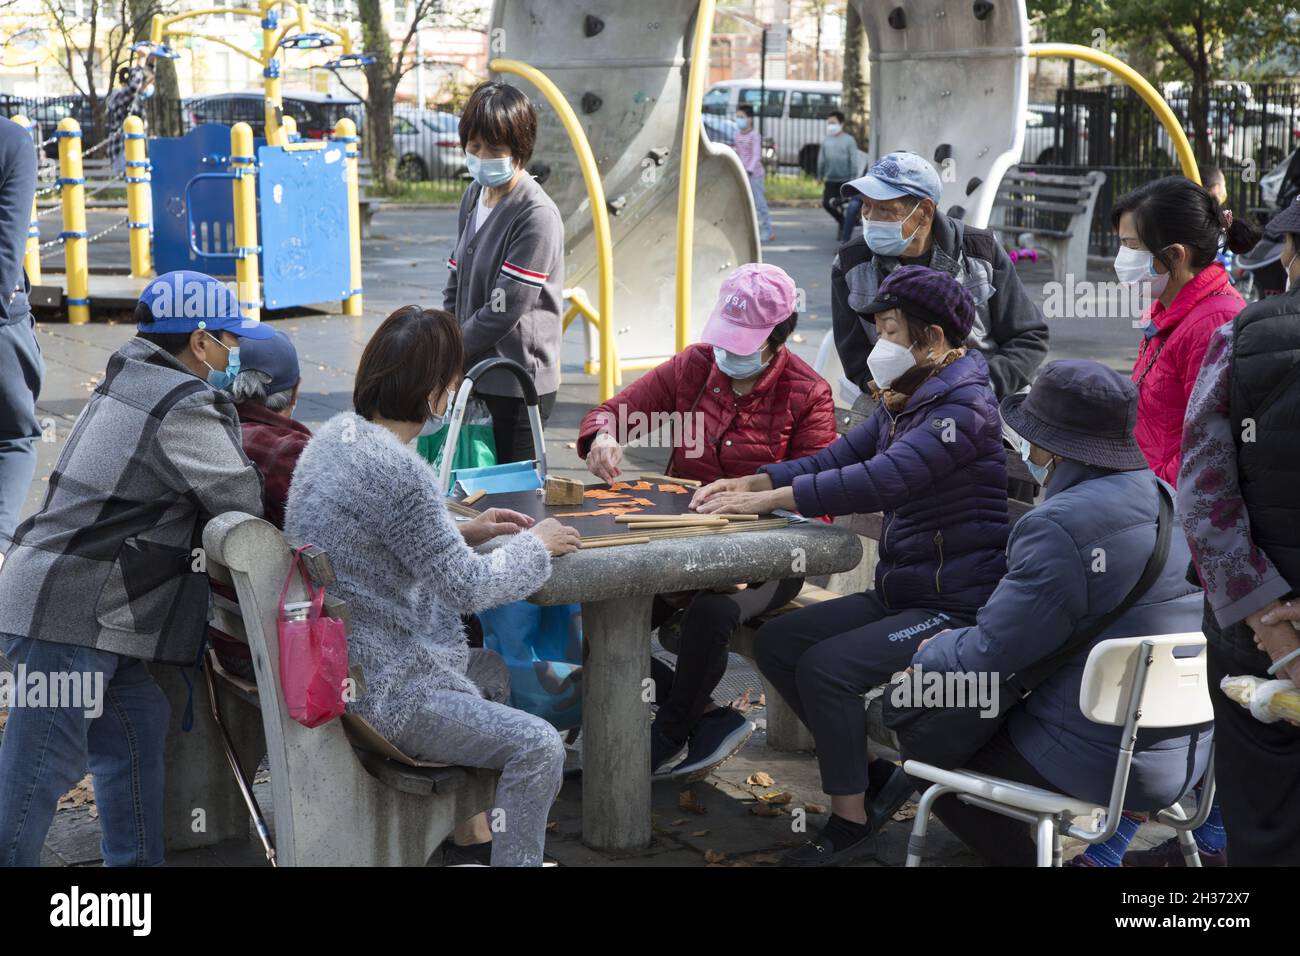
[278,545,347,727]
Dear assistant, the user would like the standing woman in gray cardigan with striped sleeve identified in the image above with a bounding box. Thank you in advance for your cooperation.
[442,83,564,462]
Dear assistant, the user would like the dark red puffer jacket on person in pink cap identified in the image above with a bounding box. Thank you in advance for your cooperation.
[577,343,835,483]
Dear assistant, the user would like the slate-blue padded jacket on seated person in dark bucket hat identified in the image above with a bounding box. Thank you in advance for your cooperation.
[913,460,1213,810]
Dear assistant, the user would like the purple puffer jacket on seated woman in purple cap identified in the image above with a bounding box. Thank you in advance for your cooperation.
[759,351,1008,613]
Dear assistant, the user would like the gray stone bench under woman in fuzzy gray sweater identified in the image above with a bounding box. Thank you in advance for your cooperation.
[153,512,497,866]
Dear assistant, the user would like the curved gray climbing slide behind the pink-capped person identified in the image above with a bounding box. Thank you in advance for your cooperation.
[489,0,761,368]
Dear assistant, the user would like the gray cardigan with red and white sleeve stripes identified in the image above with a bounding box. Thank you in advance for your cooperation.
[442,174,564,397]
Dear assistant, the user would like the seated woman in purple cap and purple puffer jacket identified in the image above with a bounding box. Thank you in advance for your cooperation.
[692,265,1008,866]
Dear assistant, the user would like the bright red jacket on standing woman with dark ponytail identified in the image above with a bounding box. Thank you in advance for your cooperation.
[1132,263,1245,485]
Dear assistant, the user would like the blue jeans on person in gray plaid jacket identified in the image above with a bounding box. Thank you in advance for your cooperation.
[0,635,170,866]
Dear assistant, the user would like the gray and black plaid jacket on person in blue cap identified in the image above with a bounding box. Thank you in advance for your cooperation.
[0,338,261,663]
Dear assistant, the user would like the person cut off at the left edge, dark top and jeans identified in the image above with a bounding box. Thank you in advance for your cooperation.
[0,118,46,562]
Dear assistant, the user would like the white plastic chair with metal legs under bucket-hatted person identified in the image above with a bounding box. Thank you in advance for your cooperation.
[904,633,1214,866]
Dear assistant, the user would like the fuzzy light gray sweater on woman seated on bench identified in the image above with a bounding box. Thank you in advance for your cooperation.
[285,412,551,740]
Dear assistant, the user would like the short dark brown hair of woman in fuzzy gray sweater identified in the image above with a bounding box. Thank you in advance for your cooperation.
[352,306,464,421]
